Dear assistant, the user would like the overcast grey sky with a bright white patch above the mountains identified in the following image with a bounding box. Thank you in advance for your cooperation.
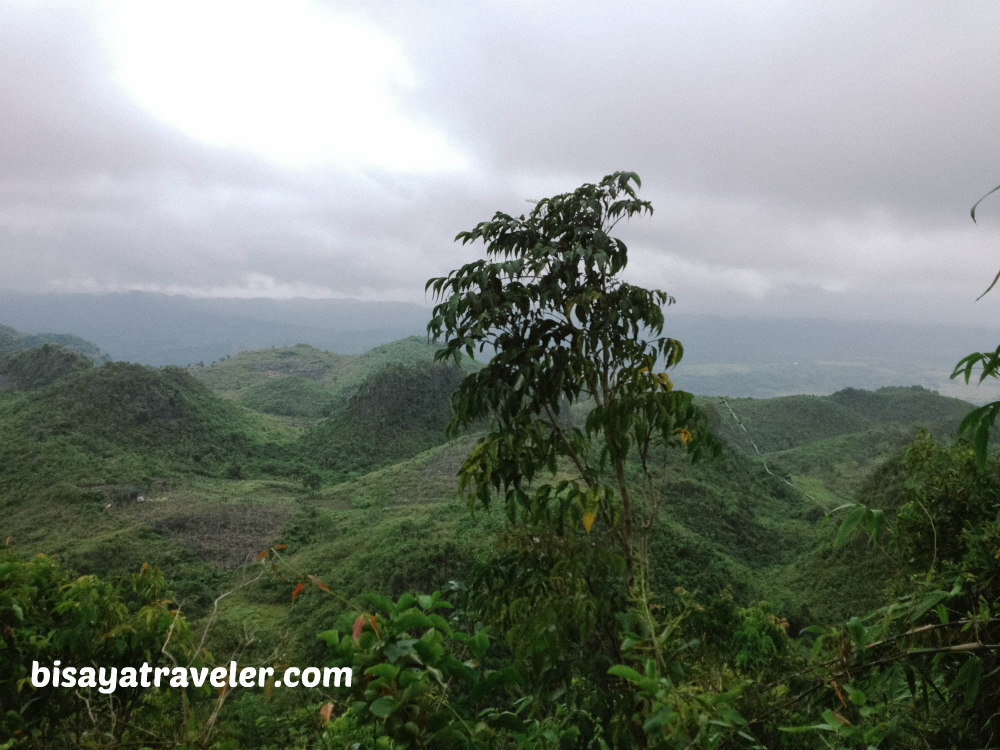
[0,0,1000,323]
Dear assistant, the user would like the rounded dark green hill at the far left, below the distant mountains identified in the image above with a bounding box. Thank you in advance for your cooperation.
[0,362,296,499]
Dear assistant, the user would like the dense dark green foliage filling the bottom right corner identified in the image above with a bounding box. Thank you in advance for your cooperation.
[789,434,1000,747]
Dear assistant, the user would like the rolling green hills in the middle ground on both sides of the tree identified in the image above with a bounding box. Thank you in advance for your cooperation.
[0,338,984,748]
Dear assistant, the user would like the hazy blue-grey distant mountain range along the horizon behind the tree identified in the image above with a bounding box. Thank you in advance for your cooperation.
[0,291,1000,402]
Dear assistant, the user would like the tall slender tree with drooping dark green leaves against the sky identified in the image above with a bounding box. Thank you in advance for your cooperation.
[425,172,716,575]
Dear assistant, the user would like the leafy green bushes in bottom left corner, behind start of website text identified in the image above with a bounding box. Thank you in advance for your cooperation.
[0,547,192,748]
